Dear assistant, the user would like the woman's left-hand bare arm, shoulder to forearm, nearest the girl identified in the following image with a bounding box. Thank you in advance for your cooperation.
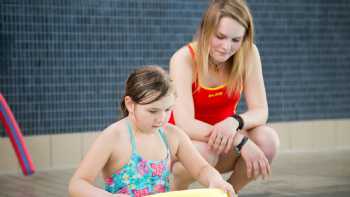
[170,46,212,142]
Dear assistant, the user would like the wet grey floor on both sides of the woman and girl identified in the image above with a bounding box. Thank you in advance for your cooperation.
[0,150,350,197]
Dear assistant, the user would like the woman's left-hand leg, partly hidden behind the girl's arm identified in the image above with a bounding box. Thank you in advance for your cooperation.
[171,141,218,190]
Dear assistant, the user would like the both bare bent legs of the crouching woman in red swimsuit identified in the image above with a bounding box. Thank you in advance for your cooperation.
[171,125,279,192]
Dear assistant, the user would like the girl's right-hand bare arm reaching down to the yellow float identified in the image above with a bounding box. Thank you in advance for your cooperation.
[173,127,234,196]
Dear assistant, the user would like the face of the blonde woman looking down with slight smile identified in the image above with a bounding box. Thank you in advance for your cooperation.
[209,17,245,63]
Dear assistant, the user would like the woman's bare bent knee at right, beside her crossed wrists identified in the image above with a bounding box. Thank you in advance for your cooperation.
[249,125,280,163]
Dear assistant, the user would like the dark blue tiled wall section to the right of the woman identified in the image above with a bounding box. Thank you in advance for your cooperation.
[249,0,350,121]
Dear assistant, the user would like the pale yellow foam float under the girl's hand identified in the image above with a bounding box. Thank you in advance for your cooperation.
[148,189,237,197]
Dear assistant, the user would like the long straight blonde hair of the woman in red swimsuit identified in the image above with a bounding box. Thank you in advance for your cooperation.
[194,0,254,95]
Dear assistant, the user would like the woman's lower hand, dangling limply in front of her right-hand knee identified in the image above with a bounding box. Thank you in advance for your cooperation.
[241,140,271,179]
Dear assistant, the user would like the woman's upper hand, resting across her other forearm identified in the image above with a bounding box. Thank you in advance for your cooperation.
[208,117,236,154]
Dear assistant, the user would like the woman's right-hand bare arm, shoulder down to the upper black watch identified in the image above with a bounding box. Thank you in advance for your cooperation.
[240,45,268,130]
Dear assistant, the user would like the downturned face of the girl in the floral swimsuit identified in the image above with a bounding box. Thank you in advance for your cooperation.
[129,94,175,132]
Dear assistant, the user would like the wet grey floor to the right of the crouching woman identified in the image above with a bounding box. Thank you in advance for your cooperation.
[240,150,350,197]
